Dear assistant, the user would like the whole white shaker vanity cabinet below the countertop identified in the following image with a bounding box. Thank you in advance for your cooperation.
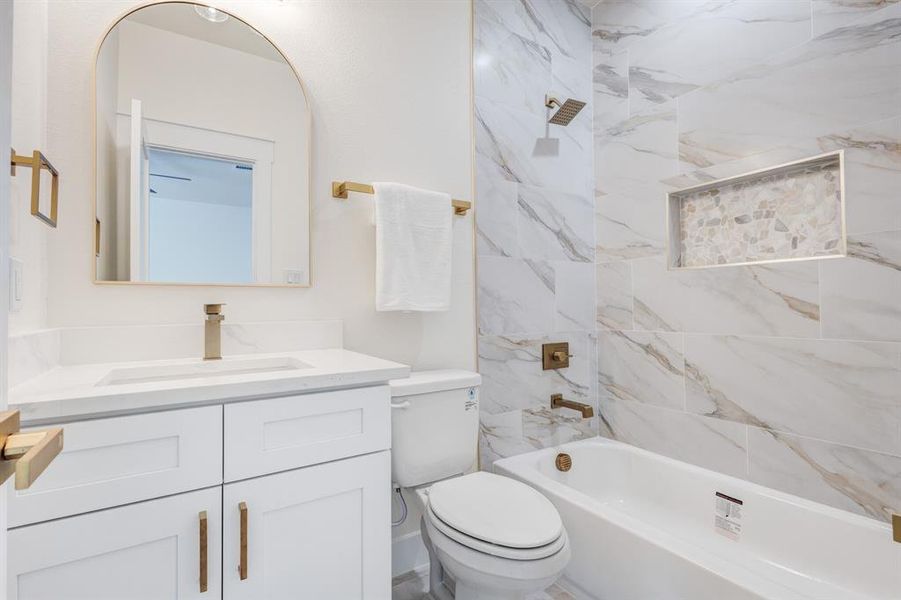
[7,385,391,600]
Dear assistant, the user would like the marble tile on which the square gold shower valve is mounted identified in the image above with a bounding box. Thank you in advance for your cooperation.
[479,332,597,414]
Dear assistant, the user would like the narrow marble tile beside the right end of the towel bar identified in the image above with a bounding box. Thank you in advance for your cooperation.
[476,176,520,258]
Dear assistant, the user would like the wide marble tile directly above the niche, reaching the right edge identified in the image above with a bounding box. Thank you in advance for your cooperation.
[678,3,901,167]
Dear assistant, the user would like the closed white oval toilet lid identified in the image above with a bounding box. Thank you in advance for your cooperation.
[429,471,563,548]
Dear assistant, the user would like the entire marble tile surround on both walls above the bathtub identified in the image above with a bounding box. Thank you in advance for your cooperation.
[475,0,901,519]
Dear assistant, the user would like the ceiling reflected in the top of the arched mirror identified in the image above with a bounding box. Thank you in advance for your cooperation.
[124,3,285,63]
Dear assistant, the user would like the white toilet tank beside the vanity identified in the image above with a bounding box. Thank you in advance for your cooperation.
[390,370,482,487]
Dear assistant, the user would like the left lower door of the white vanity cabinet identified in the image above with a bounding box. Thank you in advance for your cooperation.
[7,487,222,600]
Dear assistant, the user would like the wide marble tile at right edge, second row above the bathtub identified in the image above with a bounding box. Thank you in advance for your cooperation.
[685,335,901,454]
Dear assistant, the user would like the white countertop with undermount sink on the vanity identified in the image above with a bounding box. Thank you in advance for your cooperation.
[9,349,410,425]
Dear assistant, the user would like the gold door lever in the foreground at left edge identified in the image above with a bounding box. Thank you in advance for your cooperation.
[0,410,63,490]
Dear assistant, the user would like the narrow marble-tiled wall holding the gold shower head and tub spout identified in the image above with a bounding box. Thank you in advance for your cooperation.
[474,0,596,469]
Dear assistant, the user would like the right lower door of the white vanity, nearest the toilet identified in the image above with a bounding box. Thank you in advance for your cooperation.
[223,451,391,600]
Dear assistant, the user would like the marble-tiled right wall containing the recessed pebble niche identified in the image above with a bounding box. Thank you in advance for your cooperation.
[592,0,901,520]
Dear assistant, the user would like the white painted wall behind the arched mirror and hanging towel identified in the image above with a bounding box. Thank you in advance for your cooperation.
[24,0,475,368]
